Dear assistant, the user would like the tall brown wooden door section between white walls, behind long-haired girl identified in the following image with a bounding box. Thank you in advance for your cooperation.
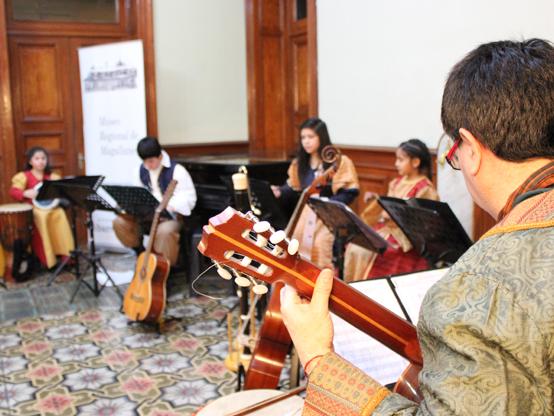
[245,0,317,158]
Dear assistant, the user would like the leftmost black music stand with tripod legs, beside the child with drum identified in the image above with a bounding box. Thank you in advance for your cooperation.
[48,177,123,302]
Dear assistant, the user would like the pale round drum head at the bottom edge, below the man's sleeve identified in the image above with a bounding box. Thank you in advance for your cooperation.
[196,389,304,416]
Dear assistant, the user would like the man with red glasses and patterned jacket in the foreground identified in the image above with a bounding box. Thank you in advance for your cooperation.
[281,39,554,415]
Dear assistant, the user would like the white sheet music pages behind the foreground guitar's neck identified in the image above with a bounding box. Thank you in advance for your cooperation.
[331,269,448,384]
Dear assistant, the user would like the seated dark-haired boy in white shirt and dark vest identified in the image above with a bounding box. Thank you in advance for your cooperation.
[113,137,196,266]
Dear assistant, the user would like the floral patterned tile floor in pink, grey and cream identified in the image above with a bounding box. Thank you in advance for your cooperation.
[0,250,274,416]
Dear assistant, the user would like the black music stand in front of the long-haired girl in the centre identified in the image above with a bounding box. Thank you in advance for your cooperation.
[308,197,388,280]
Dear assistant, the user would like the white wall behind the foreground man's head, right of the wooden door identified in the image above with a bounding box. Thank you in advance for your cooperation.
[317,0,554,236]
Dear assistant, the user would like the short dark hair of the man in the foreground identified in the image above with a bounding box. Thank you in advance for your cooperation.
[441,39,554,161]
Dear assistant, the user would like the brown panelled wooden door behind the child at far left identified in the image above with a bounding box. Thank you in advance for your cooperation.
[9,36,77,175]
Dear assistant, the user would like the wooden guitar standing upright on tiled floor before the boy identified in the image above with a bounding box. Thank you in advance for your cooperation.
[123,180,177,323]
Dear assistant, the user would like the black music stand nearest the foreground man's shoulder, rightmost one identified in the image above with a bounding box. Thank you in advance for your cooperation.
[378,196,473,266]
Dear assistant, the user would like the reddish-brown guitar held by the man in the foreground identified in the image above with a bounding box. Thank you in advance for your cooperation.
[198,207,423,401]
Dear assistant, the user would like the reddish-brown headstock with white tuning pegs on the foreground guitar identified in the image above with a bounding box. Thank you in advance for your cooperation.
[198,207,320,296]
